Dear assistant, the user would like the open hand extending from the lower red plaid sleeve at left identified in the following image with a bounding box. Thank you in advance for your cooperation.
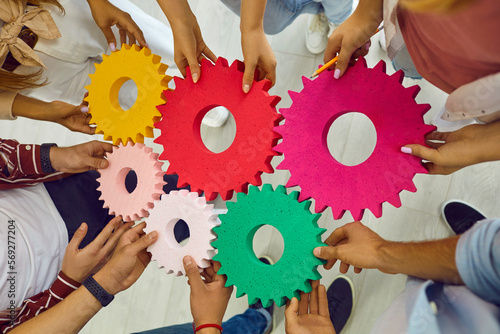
[62,217,132,283]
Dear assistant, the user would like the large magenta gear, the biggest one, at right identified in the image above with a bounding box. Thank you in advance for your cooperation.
[275,58,434,220]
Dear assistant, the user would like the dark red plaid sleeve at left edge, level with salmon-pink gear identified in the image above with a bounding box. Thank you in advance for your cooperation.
[0,139,62,189]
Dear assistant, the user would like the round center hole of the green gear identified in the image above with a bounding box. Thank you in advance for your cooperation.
[252,225,285,265]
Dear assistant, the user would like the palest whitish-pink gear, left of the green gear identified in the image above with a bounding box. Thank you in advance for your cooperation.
[145,189,220,276]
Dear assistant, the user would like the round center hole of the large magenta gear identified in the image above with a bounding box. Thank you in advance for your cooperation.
[325,111,377,166]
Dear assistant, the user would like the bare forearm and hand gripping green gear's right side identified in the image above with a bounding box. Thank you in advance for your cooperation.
[314,222,463,284]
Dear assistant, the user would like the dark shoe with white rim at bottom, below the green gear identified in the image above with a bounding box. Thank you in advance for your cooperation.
[326,275,354,334]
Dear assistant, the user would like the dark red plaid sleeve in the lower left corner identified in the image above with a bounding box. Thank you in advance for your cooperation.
[0,271,81,333]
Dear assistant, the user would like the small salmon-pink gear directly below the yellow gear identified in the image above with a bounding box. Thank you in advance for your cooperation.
[97,142,167,221]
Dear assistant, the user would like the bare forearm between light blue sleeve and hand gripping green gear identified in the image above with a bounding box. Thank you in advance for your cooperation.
[377,236,463,284]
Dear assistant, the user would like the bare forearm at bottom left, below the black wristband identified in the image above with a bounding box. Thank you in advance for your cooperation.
[10,286,102,334]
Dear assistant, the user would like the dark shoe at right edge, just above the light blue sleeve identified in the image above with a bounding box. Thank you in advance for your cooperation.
[441,199,486,234]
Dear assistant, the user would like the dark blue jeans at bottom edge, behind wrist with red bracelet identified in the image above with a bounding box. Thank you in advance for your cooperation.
[131,308,268,334]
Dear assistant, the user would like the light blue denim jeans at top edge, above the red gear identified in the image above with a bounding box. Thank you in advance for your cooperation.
[221,0,352,35]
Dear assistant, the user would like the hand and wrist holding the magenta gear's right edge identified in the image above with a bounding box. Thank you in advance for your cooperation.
[401,121,500,174]
